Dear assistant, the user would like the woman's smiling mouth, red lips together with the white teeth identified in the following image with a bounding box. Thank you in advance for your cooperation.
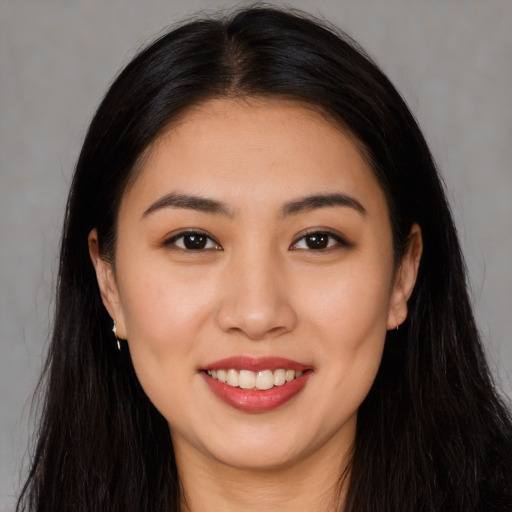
[200,357,314,412]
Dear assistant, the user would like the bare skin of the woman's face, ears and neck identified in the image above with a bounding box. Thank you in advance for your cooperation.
[89,99,421,511]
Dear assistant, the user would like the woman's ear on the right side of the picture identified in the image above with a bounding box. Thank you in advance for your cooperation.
[388,224,423,329]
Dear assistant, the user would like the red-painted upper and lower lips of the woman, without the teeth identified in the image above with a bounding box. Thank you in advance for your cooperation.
[200,356,313,413]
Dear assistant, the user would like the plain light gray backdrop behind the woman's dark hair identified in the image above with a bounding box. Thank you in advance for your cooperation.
[0,0,512,510]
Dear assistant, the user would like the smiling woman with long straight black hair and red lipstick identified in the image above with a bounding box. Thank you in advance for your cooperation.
[18,8,512,512]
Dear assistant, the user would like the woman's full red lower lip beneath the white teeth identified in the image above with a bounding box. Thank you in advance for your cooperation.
[201,371,313,412]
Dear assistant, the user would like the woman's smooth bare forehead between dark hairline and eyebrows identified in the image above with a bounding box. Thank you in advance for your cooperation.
[123,98,386,216]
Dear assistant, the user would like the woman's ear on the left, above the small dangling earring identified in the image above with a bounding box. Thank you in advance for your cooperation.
[87,229,126,339]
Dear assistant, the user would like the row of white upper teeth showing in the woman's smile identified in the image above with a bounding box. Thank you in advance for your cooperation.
[207,368,302,390]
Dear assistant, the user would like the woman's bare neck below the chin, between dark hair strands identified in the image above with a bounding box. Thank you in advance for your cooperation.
[176,432,348,512]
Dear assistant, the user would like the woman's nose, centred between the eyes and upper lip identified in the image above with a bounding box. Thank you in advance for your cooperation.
[217,249,297,340]
